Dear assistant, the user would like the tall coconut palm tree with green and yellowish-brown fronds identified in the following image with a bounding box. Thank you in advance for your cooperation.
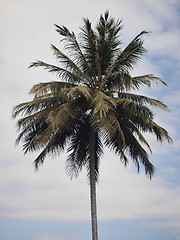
[12,11,171,240]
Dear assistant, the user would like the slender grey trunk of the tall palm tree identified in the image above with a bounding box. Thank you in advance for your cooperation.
[90,130,98,240]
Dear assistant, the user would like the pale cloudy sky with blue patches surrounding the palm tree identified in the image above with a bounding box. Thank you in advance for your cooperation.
[0,0,180,240]
